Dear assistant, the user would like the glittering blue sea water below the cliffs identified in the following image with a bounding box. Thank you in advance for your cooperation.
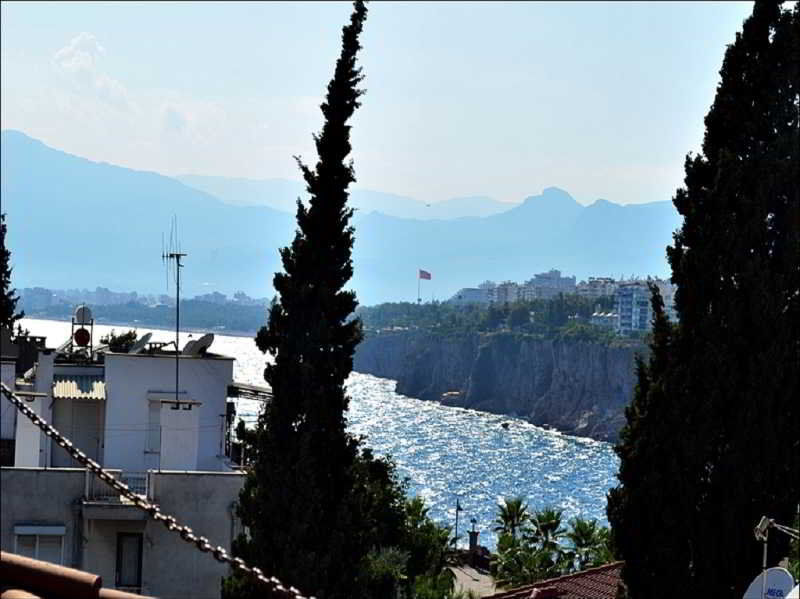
[17,318,619,550]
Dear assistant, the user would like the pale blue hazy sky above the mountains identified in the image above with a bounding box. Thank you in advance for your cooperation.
[0,2,752,203]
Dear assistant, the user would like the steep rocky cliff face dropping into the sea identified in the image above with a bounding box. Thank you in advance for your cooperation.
[354,331,645,441]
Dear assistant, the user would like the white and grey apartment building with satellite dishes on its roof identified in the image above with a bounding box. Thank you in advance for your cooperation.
[0,312,264,599]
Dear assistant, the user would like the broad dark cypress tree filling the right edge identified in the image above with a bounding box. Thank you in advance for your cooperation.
[608,0,800,598]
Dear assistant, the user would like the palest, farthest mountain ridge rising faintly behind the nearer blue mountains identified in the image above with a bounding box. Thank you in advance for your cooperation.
[175,175,514,220]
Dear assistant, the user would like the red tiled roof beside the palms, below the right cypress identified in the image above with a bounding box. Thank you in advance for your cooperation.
[485,562,624,599]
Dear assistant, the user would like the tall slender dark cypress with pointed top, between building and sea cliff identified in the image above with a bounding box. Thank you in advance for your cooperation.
[230,0,392,598]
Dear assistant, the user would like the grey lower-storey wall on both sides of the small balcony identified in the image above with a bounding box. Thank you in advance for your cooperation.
[0,468,244,599]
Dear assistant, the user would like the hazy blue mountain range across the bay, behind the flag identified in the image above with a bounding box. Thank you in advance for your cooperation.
[0,131,680,304]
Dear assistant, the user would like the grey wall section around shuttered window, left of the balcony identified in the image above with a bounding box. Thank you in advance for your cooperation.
[0,468,85,567]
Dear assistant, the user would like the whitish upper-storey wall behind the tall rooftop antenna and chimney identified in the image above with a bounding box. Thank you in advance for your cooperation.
[104,354,233,471]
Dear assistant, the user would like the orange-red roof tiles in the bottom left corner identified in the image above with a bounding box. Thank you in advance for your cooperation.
[0,551,152,599]
